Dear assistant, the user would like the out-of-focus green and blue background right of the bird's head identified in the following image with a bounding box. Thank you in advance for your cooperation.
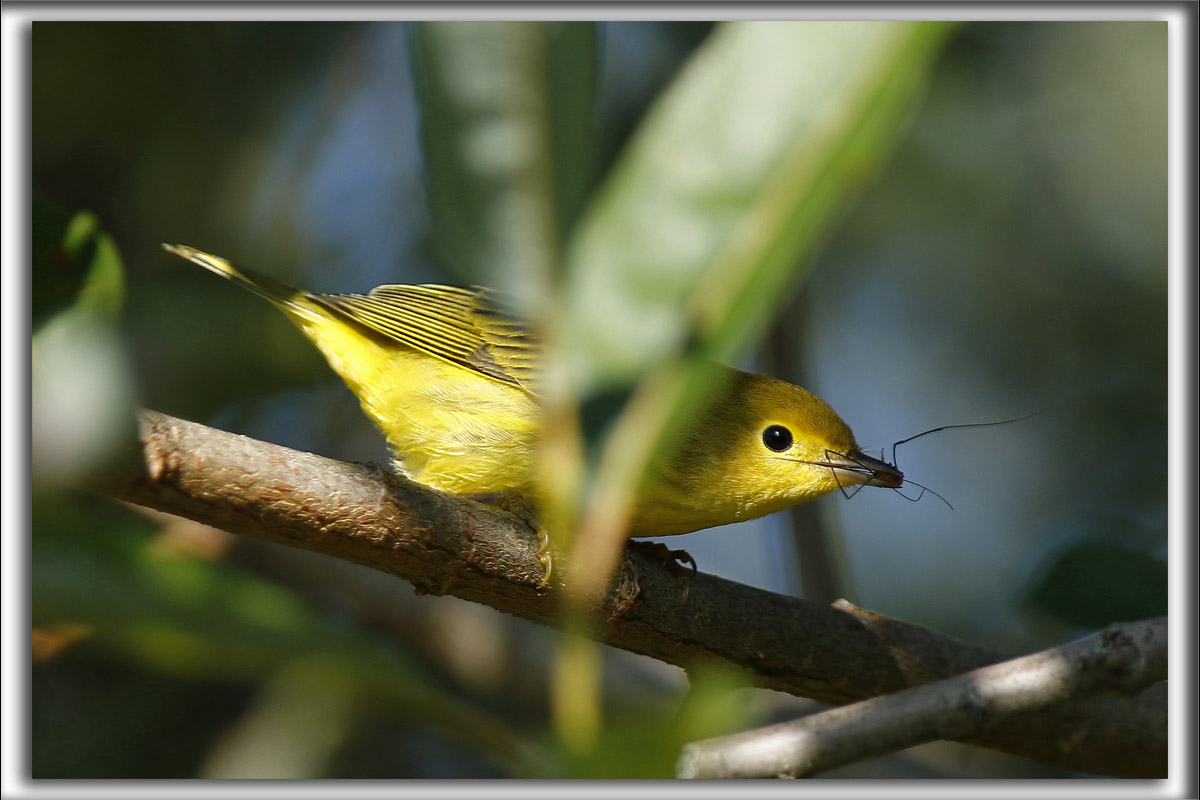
[797,23,1169,651]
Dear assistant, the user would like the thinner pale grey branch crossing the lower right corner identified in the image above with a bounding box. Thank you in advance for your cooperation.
[676,616,1166,778]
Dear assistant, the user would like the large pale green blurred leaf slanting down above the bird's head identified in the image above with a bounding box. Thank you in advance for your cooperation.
[568,22,952,392]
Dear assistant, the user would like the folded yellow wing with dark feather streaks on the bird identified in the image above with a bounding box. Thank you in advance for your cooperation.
[305,284,540,392]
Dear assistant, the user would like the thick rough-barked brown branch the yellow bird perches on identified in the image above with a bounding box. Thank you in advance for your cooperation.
[103,410,1166,777]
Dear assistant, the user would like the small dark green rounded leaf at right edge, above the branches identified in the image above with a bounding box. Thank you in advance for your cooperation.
[1028,542,1168,627]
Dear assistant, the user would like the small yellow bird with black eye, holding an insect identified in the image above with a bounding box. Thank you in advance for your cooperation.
[163,245,904,536]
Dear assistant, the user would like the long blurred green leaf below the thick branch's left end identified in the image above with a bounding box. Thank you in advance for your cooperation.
[32,493,532,768]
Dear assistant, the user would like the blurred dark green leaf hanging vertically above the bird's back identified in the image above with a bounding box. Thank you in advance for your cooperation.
[412,22,596,307]
